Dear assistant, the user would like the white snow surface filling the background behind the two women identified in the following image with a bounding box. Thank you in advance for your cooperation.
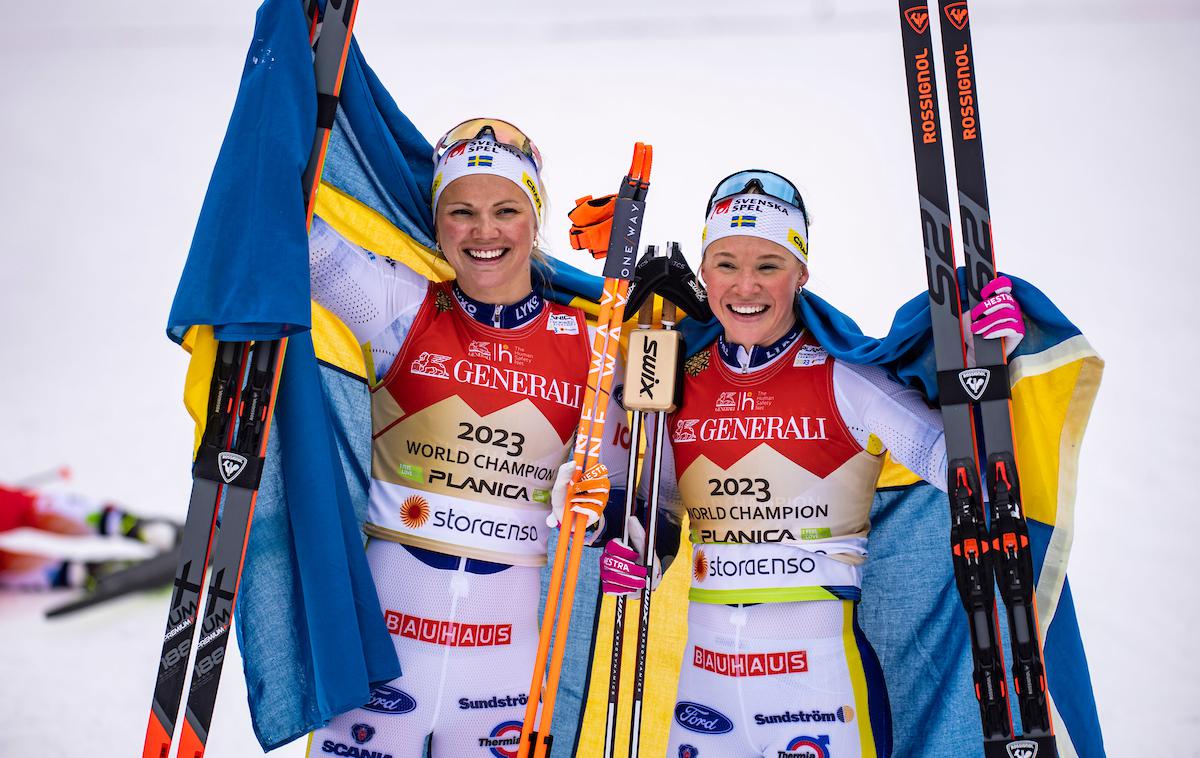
[0,0,1200,757]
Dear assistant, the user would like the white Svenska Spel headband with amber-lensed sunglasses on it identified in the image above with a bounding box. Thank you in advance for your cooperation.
[431,119,546,220]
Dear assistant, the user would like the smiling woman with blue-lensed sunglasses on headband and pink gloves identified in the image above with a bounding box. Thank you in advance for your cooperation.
[606,170,1021,758]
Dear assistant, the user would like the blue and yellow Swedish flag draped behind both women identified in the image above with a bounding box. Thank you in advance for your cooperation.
[168,0,1103,758]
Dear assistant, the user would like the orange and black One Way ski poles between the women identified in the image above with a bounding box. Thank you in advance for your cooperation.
[517,143,653,758]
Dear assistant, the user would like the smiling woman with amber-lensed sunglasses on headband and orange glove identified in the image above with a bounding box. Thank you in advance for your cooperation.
[300,119,628,758]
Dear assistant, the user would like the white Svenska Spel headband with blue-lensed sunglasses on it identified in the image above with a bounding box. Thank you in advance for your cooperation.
[701,169,809,266]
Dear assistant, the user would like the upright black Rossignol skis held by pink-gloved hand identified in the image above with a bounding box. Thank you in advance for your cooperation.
[900,0,1058,758]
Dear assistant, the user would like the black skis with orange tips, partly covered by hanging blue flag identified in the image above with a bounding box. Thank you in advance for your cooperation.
[142,0,358,758]
